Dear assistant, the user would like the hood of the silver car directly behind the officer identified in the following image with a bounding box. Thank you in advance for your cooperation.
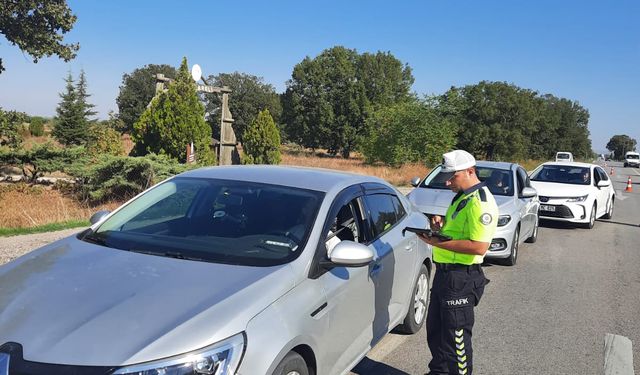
[407,188,515,216]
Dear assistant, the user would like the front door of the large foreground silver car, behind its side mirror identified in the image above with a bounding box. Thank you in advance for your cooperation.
[309,185,376,374]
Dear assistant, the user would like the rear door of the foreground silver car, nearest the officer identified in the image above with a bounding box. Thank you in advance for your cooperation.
[364,185,417,344]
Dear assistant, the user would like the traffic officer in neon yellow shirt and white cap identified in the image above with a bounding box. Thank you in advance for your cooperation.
[420,150,498,375]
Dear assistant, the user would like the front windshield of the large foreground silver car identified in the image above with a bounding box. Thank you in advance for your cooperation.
[81,178,324,266]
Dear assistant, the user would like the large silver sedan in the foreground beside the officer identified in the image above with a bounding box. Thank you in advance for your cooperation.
[0,166,431,375]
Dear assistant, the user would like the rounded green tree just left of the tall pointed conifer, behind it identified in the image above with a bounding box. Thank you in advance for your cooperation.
[116,64,176,133]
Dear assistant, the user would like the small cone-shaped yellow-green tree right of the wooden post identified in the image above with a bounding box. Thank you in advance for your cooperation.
[242,109,280,164]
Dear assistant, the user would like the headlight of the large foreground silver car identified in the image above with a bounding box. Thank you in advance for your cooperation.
[114,333,245,375]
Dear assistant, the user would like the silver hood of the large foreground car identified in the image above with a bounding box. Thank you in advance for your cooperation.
[0,237,294,366]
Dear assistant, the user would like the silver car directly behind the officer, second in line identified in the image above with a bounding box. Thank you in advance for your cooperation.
[408,161,540,266]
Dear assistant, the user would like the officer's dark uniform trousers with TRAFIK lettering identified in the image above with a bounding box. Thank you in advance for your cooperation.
[427,263,489,375]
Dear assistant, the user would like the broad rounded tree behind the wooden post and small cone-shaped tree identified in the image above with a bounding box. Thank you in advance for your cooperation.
[205,72,282,142]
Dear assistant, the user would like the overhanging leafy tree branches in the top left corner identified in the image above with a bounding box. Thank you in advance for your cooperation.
[0,0,80,73]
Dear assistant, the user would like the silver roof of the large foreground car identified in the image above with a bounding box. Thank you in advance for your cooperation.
[178,165,390,192]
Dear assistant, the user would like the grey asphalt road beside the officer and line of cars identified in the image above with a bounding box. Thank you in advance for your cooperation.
[351,163,640,375]
